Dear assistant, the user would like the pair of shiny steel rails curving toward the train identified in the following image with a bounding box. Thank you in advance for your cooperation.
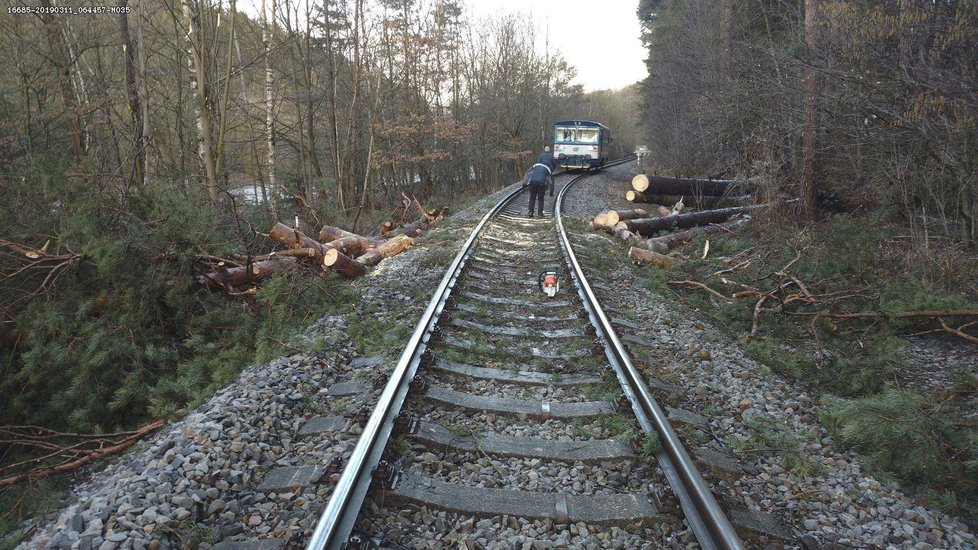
[307,159,743,550]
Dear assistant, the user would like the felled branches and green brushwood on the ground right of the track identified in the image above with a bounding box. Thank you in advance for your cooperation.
[641,212,978,525]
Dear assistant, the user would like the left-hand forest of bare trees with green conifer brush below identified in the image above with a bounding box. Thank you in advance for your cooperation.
[0,0,637,431]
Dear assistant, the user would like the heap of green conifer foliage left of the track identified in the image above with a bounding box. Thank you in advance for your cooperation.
[0,169,349,431]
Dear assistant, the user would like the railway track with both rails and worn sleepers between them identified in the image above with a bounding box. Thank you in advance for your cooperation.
[308,164,742,549]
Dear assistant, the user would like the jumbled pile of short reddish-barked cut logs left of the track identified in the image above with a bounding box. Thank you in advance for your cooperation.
[197,197,447,295]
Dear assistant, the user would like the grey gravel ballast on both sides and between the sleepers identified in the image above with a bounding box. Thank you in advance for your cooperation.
[18,169,976,550]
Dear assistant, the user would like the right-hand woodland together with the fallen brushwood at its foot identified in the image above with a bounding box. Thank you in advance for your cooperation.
[638,0,978,524]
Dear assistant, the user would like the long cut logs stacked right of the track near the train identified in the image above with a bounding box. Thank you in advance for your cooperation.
[591,174,766,267]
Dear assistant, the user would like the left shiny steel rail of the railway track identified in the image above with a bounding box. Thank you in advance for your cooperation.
[306,182,523,550]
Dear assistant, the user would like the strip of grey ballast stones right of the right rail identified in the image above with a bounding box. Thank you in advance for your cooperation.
[565,162,976,550]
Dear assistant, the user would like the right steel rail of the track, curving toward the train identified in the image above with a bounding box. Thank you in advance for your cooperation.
[554,168,744,550]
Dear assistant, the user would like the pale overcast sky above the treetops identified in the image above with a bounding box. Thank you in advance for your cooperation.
[466,0,648,92]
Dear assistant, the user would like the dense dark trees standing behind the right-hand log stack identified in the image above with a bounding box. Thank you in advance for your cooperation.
[638,0,978,242]
